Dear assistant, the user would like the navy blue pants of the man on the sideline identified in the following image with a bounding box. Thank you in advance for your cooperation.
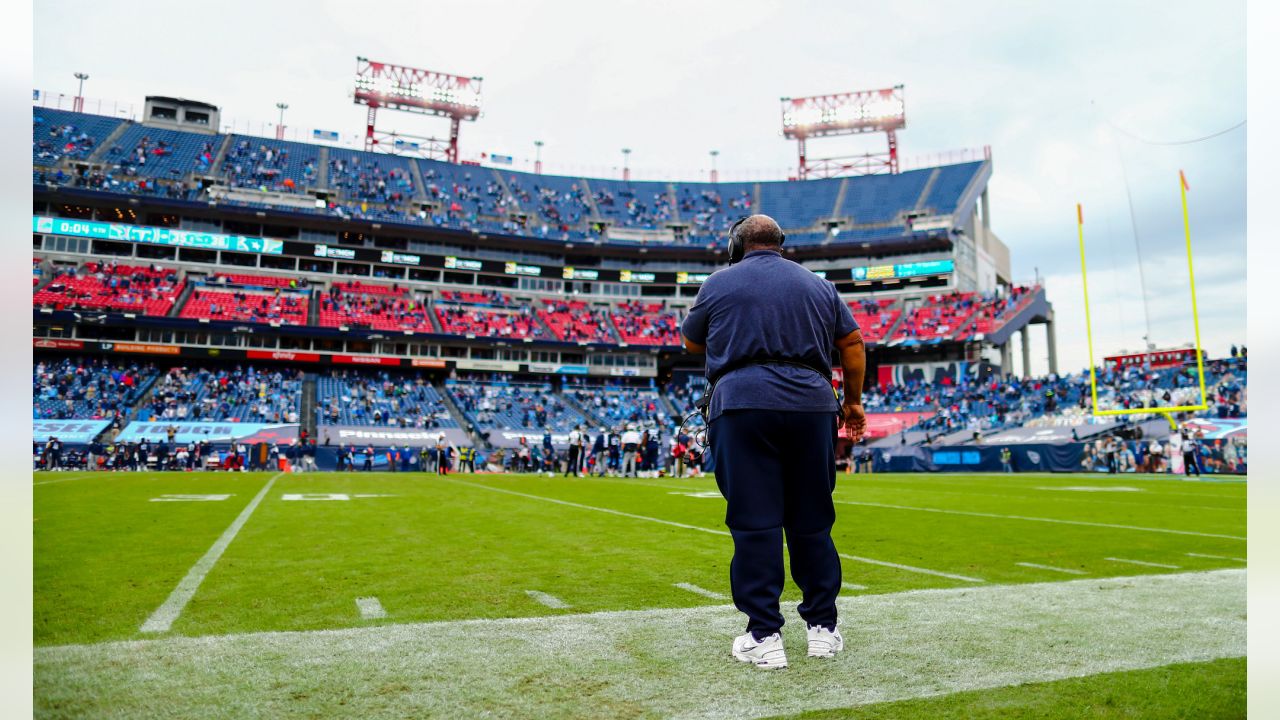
[708,410,841,638]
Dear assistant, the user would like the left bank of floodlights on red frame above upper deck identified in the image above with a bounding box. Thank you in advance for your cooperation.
[353,58,484,163]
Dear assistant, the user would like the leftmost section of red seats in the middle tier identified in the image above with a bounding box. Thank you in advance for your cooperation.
[32,261,183,315]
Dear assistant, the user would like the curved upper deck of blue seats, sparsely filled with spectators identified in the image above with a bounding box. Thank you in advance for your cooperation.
[32,108,989,247]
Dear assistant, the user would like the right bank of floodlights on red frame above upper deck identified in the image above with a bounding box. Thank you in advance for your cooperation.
[782,85,906,179]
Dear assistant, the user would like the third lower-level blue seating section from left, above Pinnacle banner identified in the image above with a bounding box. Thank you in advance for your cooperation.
[316,370,458,429]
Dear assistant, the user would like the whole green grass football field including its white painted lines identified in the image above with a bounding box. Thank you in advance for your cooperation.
[33,473,1245,719]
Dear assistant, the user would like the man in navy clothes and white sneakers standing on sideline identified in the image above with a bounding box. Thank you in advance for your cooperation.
[681,215,867,667]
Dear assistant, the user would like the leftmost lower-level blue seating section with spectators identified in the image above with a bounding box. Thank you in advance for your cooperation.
[31,357,156,420]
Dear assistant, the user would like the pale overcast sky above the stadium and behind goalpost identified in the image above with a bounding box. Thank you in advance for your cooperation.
[35,0,1245,370]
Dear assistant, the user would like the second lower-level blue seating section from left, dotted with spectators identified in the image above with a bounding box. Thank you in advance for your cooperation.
[138,366,302,423]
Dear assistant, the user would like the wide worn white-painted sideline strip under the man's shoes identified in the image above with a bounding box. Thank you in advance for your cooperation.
[35,569,1247,719]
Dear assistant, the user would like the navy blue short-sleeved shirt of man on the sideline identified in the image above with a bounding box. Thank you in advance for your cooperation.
[681,250,858,420]
